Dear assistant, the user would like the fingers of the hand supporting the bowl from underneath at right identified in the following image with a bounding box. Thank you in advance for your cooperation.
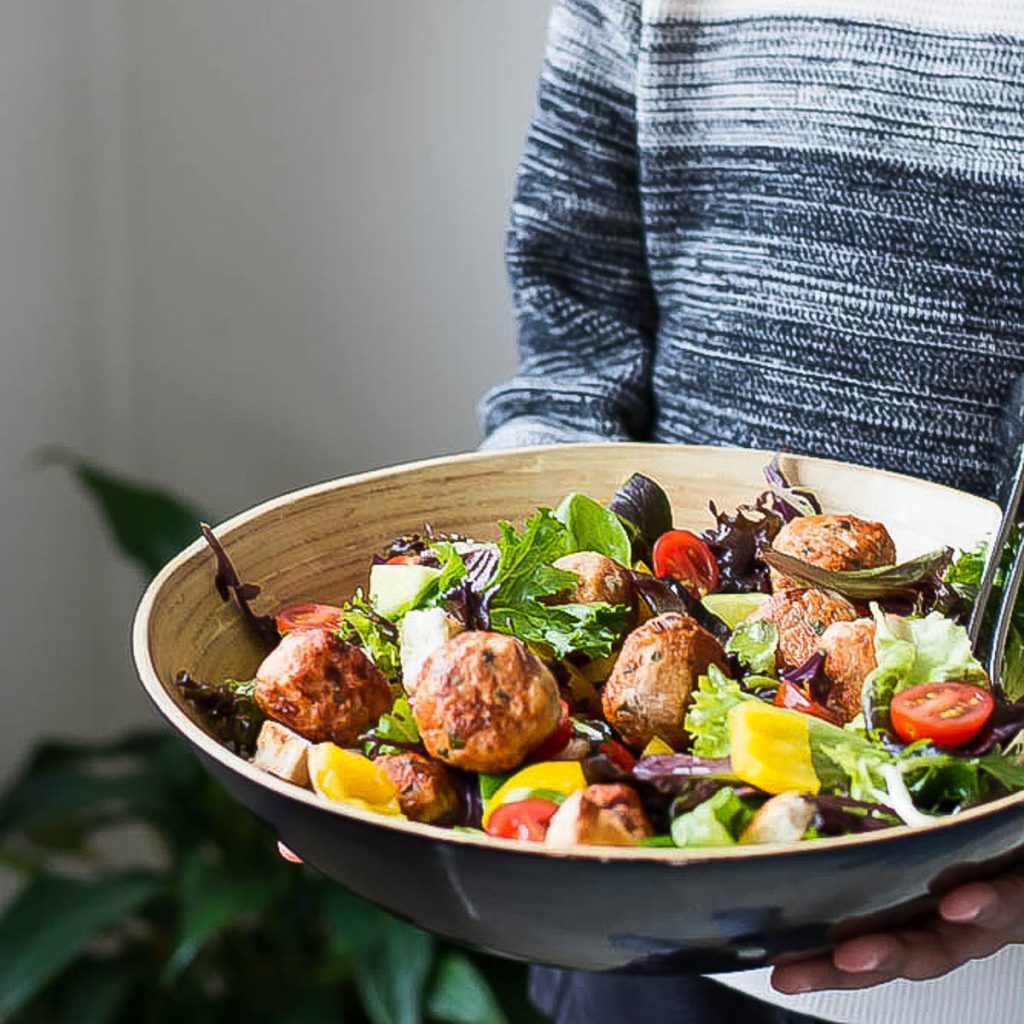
[771,868,1024,995]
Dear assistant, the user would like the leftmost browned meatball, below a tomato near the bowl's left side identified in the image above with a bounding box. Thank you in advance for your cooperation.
[255,630,393,746]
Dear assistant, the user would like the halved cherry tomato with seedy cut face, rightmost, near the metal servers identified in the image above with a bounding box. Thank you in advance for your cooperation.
[889,683,995,746]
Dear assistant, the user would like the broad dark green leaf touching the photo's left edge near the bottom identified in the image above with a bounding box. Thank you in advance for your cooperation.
[0,871,160,1015]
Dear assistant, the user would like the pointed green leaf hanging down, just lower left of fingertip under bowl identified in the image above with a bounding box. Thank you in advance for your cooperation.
[161,855,274,984]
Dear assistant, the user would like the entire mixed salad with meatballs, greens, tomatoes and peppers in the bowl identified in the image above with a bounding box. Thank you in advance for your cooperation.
[177,458,1024,847]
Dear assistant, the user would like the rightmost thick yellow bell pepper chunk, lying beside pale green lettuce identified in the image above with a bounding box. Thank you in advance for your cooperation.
[729,700,821,794]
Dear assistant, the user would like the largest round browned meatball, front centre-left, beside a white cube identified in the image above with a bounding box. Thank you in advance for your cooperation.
[413,631,561,771]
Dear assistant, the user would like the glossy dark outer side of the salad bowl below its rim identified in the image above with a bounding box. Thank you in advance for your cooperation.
[197,749,1024,974]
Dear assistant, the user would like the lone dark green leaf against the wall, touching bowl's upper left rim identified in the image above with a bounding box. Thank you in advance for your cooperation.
[36,447,210,577]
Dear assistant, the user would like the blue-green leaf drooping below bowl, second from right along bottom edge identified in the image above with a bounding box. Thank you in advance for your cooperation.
[355,918,434,1024]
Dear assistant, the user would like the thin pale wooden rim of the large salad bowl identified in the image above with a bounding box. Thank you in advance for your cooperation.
[132,441,1024,866]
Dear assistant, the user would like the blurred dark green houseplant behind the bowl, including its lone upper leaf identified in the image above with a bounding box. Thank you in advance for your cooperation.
[0,451,542,1024]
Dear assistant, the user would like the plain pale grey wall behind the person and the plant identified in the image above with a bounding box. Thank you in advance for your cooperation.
[0,0,549,775]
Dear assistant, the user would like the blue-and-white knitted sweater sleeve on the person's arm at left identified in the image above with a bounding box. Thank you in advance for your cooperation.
[480,0,657,447]
